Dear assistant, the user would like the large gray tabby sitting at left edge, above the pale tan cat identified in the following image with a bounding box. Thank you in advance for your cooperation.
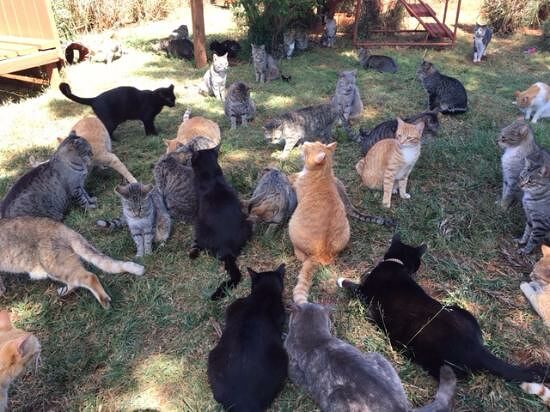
[0,132,97,221]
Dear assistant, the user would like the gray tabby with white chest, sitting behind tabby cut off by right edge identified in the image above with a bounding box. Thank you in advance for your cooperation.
[497,118,540,210]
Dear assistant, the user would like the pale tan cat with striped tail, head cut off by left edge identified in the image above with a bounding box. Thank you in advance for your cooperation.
[0,216,145,309]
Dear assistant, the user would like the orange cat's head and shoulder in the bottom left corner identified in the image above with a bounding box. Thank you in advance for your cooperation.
[0,310,40,412]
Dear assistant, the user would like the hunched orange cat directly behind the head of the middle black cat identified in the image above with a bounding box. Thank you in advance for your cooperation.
[164,109,221,153]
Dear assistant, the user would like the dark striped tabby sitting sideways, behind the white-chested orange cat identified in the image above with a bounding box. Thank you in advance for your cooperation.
[416,60,468,114]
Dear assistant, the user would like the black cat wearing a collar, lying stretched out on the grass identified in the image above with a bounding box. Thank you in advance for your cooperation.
[338,235,550,382]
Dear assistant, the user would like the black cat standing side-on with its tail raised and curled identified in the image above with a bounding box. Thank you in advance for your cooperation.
[59,83,176,137]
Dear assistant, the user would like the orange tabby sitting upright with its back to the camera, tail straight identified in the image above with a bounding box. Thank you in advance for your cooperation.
[288,142,350,303]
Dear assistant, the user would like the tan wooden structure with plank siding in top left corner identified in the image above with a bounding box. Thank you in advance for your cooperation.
[0,0,63,84]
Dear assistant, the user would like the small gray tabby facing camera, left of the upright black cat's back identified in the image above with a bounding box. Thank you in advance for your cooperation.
[96,183,172,257]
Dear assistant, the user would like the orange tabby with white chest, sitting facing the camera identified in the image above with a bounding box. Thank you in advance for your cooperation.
[355,117,424,207]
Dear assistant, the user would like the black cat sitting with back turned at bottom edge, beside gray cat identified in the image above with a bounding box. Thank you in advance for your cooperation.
[208,264,288,412]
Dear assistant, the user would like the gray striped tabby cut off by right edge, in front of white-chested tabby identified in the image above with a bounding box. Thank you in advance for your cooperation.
[519,150,550,254]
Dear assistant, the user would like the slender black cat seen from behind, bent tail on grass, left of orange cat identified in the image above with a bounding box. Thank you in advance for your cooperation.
[189,148,252,300]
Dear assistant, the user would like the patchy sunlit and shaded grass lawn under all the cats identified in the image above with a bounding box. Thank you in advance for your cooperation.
[0,3,550,412]
